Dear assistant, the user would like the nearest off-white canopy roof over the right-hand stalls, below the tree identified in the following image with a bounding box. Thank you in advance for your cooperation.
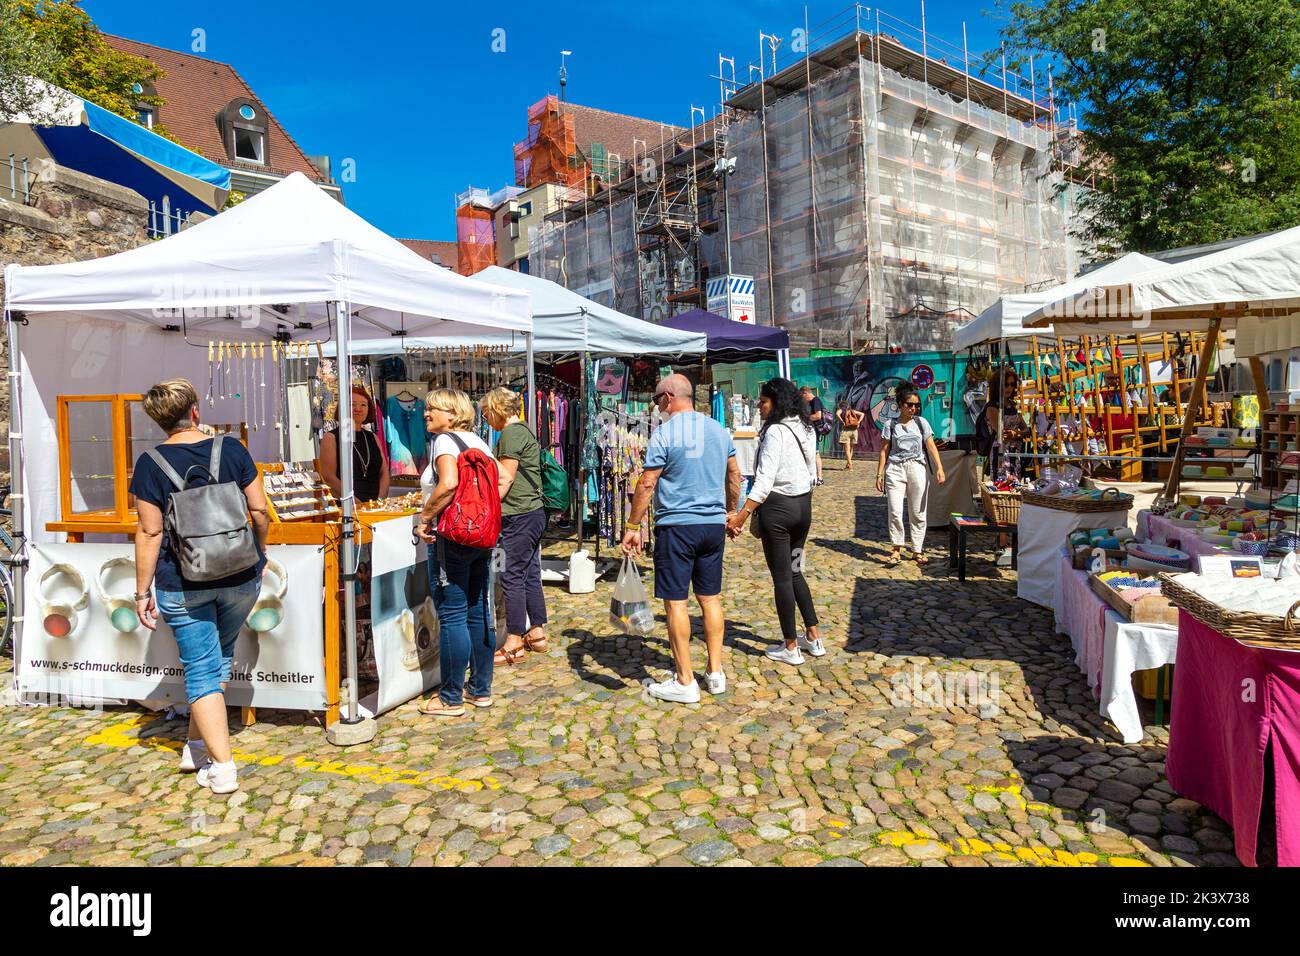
[1024,226,1300,336]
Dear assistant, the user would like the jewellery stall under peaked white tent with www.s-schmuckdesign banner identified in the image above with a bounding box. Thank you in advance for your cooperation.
[5,174,532,724]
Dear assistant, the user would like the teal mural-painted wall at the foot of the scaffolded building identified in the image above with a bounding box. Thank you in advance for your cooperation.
[714,351,987,454]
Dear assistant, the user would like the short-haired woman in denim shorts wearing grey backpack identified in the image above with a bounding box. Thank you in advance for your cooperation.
[130,378,270,793]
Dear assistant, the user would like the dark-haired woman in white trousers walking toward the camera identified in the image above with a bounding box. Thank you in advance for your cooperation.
[876,384,946,567]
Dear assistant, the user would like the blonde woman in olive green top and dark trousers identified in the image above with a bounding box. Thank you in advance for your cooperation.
[482,389,546,663]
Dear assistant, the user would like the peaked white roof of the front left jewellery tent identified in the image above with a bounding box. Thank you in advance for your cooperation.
[5,173,533,342]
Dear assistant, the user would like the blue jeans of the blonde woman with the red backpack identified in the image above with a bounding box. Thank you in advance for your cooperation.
[429,541,497,706]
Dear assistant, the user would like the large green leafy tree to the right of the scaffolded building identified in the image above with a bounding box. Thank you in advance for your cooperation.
[1002,0,1300,254]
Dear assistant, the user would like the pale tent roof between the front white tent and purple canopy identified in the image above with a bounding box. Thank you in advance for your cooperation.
[332,265,709,355]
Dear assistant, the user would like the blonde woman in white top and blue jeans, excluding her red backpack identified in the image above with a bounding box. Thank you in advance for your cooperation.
[416,389,497,717]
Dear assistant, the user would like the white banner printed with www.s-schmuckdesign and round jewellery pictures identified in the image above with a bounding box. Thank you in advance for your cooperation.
[17,544,325,710]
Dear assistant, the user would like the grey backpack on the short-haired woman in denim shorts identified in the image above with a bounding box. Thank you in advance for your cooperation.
[150,436,261,581]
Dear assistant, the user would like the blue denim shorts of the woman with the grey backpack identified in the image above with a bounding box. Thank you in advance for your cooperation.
[156,579,261,704]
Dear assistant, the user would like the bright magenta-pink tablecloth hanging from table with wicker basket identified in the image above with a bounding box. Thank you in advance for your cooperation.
[1165,611,1300,866]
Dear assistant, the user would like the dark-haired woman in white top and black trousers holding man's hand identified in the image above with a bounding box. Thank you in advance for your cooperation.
[727,378,826,665]
